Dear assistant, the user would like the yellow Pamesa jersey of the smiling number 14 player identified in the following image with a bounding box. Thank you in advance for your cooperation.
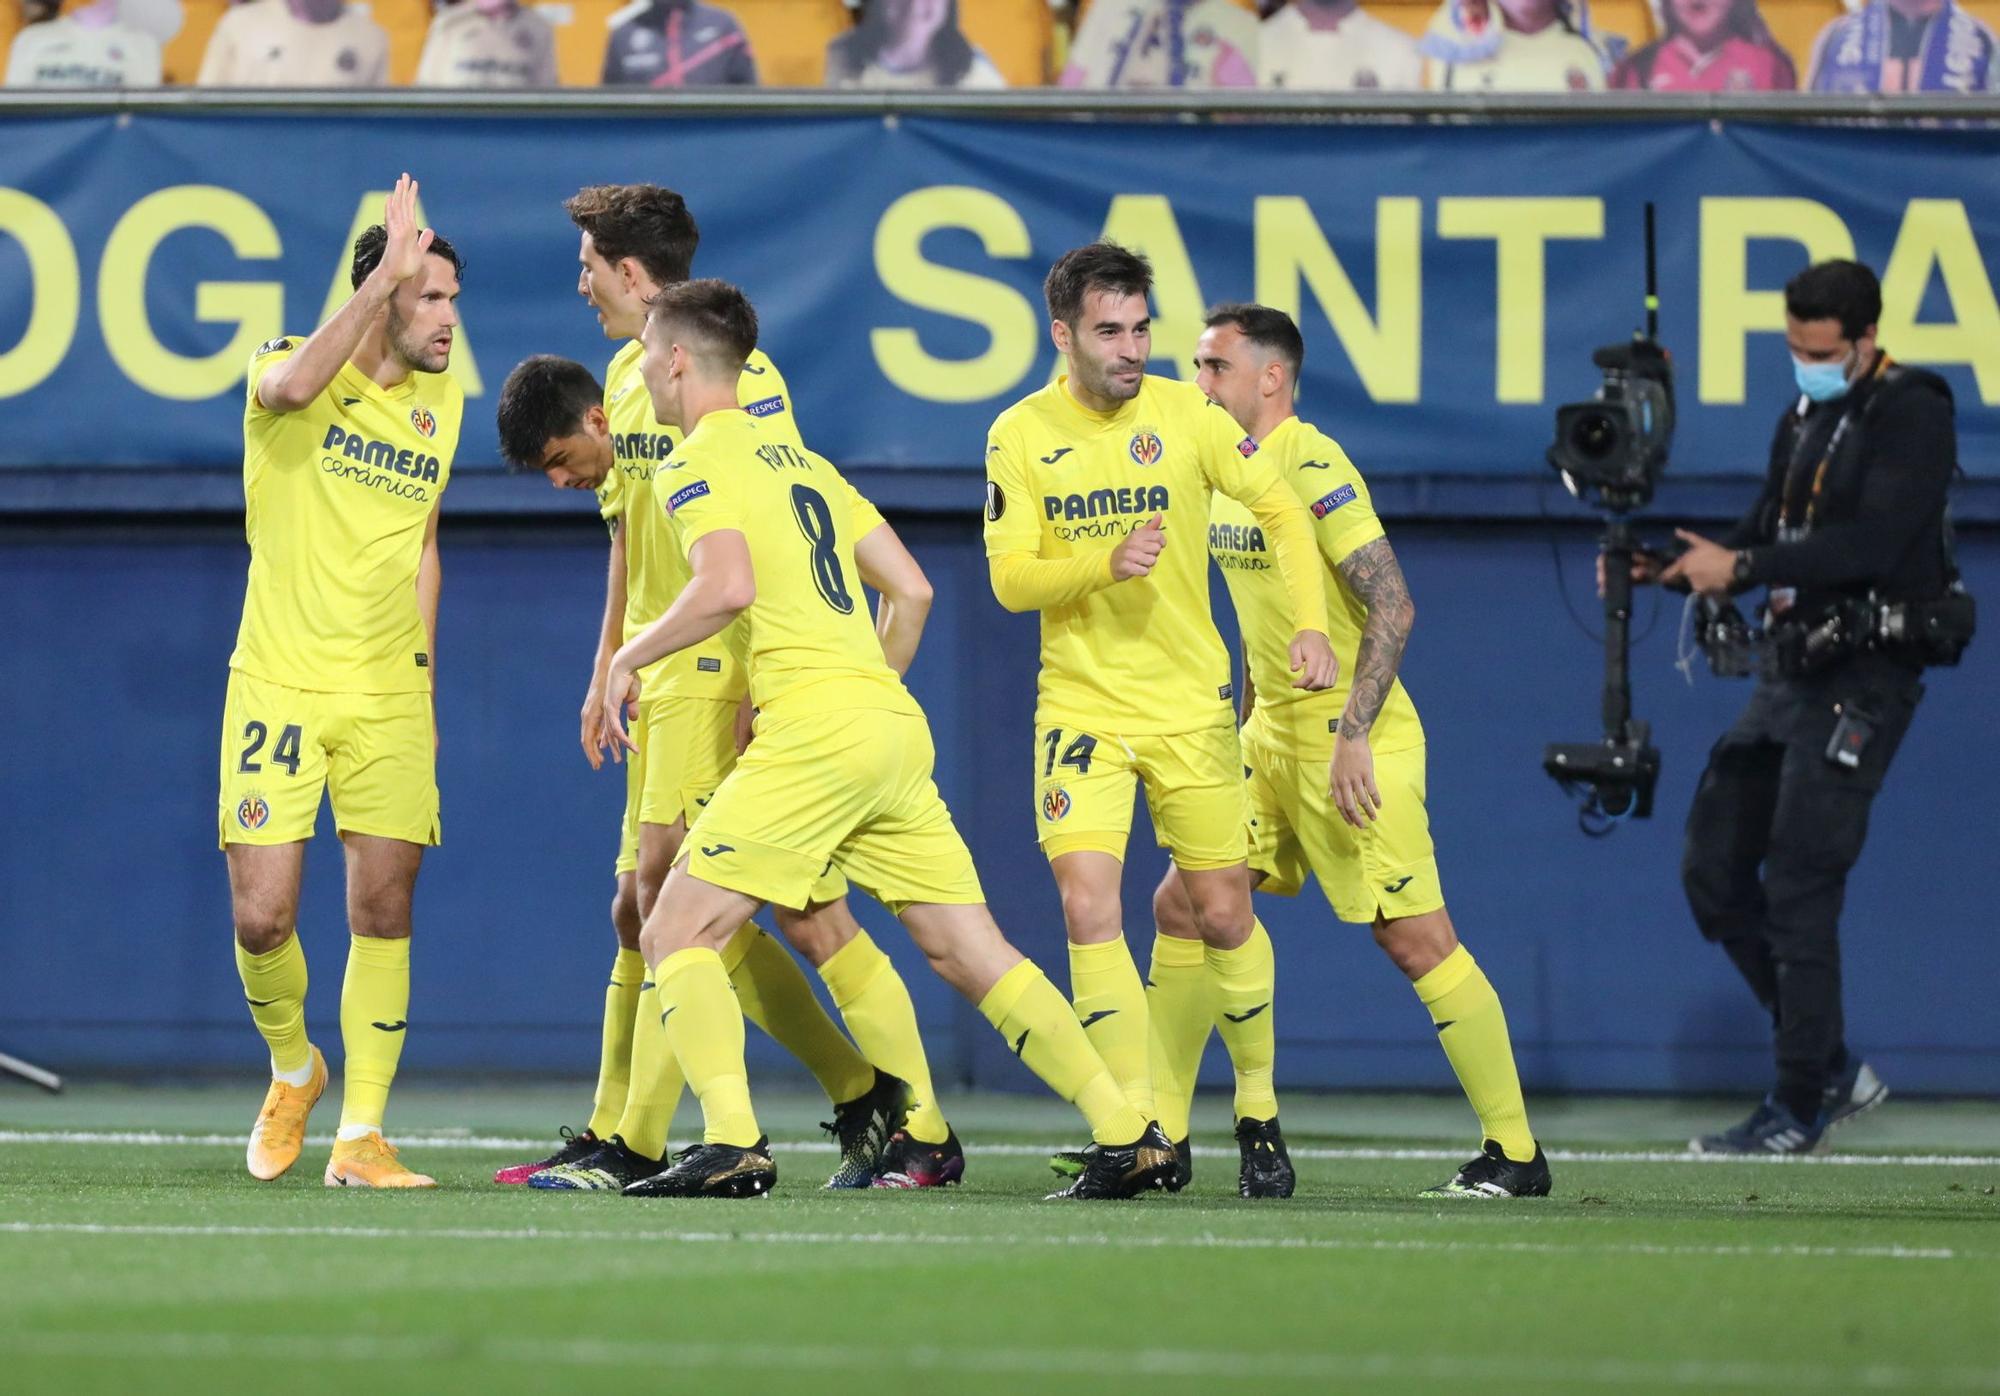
[986,374,1290,736]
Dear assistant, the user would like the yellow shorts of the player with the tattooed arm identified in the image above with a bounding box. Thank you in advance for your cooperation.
[1244,736,1444,924]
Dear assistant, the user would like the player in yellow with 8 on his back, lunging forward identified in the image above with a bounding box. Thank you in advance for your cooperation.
[604,282,1174,1198]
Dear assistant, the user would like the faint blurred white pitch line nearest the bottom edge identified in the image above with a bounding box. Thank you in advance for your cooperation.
[0,1332,2000,1392]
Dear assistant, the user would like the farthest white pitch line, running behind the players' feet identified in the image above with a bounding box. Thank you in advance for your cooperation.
[0,1130,2000,1168]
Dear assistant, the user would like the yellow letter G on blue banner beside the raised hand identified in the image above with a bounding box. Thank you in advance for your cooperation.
[98,184,284,402]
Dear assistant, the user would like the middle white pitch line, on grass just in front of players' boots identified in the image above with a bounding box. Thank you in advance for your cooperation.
[0,1222,1986,1260]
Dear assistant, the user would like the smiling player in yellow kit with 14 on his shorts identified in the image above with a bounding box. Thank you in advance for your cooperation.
[986,242,1334,1196]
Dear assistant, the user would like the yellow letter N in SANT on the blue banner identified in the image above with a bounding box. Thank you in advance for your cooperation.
[1254,194,1424,402]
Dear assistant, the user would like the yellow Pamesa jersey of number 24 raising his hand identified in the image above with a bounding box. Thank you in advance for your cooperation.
[230,338,466,694]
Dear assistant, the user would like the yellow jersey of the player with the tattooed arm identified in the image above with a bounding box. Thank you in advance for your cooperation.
[1208,416,1424,756]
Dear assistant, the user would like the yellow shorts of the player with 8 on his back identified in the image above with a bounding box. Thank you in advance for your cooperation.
[686,708,986,914]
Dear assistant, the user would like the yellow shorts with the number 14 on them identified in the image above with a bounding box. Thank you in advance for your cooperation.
[1034,726,1248,872]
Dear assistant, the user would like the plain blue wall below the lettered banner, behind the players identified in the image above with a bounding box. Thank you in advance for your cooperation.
[0,516,2000,1092]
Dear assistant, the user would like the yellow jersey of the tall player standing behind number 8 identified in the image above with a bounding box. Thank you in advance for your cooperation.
[598,340,798,702]
